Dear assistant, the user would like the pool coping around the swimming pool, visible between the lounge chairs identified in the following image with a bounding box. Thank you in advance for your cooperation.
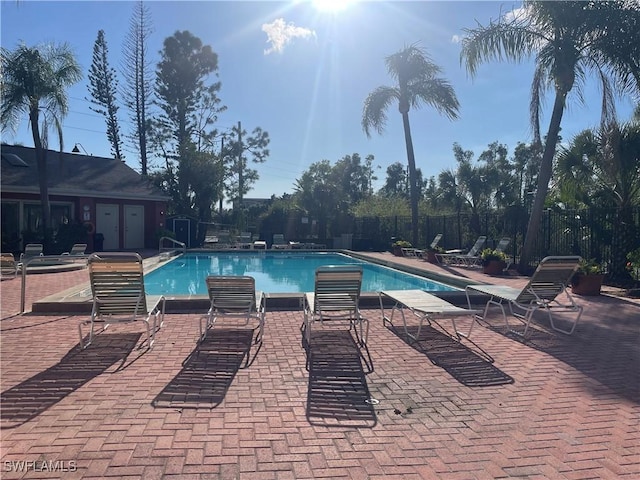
[31,249,484,314]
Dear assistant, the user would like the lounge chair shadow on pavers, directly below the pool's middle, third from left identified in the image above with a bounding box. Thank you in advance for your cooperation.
[306,330,377,428]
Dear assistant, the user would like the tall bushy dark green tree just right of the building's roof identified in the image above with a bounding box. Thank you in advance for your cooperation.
[152,31,224,222]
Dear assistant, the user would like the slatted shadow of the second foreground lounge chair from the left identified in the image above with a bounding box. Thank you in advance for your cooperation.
[151,328,262,408]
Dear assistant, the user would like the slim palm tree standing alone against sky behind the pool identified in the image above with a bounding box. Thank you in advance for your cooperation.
[362,45,459,245]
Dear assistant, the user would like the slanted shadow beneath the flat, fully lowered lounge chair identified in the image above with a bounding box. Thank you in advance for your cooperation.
[387,322,514,387]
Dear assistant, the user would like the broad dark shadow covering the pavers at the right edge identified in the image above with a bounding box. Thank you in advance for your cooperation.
[483,296,640,404]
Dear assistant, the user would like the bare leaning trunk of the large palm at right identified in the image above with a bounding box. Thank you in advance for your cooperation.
[518,91,567,273]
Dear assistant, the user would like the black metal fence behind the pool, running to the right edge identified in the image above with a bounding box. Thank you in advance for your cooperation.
[353,207,640,272]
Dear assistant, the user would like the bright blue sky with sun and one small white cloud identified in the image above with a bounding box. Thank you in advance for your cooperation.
[0,0,632,198]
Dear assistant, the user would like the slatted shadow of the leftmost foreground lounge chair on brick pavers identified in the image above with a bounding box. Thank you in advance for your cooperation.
[0,333,141,429]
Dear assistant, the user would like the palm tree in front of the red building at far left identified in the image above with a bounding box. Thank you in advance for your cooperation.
[0,44,82,248]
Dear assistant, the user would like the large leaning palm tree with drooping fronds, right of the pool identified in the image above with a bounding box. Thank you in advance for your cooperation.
[460,0,640,270]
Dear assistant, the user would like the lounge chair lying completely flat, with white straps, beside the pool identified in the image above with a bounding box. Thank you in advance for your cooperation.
[379,290,480,341]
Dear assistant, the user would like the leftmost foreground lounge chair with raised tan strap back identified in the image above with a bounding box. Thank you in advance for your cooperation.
[78,252,165,349]
